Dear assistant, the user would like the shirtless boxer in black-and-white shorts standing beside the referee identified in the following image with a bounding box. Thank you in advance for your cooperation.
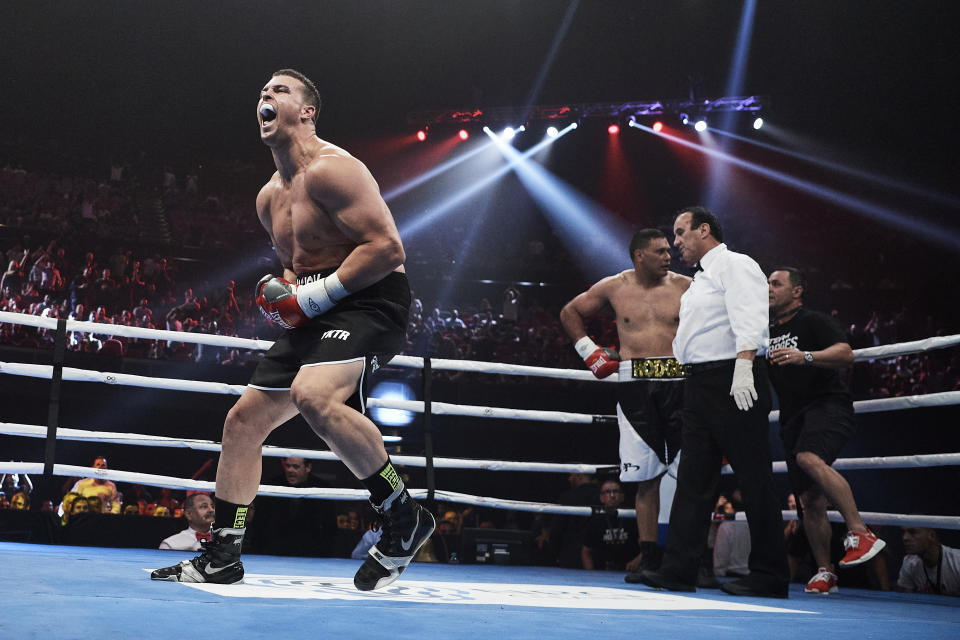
[560,229,691,580]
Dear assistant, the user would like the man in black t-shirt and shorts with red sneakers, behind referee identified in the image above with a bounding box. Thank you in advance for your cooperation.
[767,267,886,594]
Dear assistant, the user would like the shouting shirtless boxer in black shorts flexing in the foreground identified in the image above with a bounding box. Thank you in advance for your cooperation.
[151,69,435,591]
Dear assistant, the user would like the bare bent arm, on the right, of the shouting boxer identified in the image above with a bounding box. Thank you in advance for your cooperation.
[306,156,406,291]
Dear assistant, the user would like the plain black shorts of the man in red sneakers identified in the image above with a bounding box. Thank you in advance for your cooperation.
[780,396,857,497]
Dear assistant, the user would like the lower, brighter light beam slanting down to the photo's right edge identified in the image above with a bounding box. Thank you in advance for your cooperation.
[629,122,960,250]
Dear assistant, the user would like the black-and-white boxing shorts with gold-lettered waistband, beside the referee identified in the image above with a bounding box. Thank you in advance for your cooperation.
[617,358,685,482]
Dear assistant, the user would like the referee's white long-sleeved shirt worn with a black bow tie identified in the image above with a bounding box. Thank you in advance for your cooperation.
[673,243,770,364]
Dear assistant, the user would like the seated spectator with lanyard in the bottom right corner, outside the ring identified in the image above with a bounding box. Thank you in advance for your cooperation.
[896,527,960,596]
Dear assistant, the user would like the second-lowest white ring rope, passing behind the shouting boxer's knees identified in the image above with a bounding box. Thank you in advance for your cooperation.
[0,422,960,474]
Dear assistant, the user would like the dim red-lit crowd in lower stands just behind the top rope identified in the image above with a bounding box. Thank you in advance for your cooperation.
[0,228,960,398]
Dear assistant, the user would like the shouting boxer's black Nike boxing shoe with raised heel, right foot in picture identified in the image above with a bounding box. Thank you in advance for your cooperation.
[353,489,437,591]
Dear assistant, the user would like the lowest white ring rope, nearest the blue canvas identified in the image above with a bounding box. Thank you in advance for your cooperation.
[0,462,960,529]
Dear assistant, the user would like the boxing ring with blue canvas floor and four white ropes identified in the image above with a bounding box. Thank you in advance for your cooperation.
[0,312,960,638]
